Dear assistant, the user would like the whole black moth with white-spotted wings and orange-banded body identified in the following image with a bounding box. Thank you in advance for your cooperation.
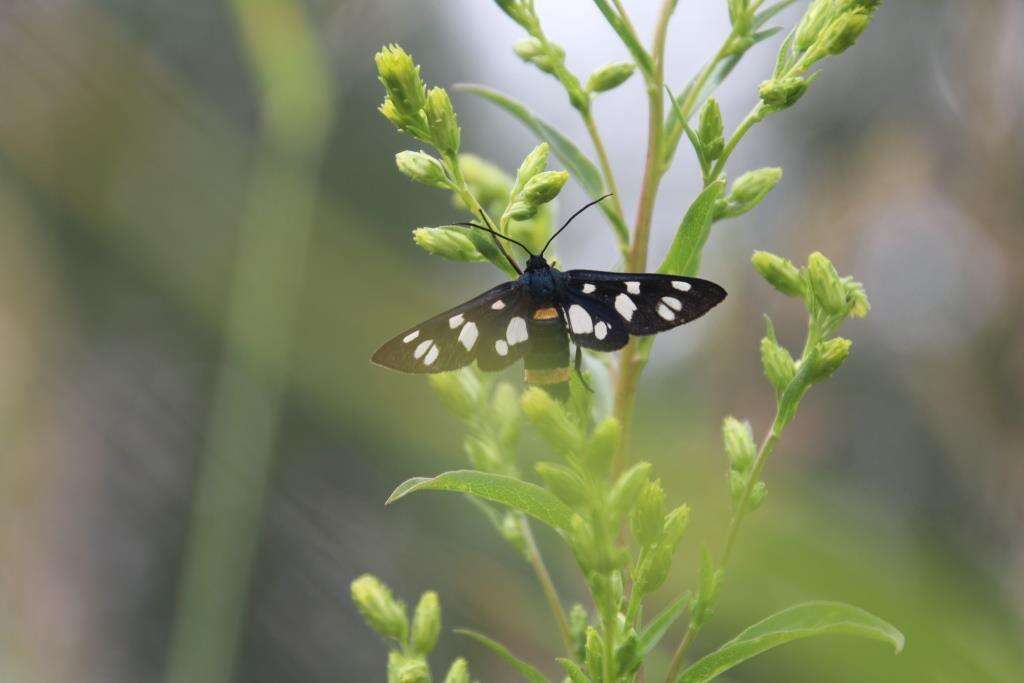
[373,197,725,399]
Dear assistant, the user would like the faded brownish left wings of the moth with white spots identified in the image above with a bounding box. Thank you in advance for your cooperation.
[372,281,528,374]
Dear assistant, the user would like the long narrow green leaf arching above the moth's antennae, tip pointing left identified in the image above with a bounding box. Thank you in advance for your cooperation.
[453,83,630,243]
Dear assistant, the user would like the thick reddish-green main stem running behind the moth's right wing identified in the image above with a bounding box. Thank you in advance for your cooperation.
[612,0,676,476]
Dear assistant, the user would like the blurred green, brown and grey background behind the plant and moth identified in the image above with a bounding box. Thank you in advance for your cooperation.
[0,0,1024,683]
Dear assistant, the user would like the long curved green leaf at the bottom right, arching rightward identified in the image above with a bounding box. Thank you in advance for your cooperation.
[677,602,904,683]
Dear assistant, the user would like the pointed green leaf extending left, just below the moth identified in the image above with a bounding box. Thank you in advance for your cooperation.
[385,470,573,531]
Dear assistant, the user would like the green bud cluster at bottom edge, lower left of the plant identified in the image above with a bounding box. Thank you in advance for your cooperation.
[350,573,469,683]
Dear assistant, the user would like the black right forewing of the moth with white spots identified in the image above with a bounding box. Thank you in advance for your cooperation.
[563,270,725,335]
